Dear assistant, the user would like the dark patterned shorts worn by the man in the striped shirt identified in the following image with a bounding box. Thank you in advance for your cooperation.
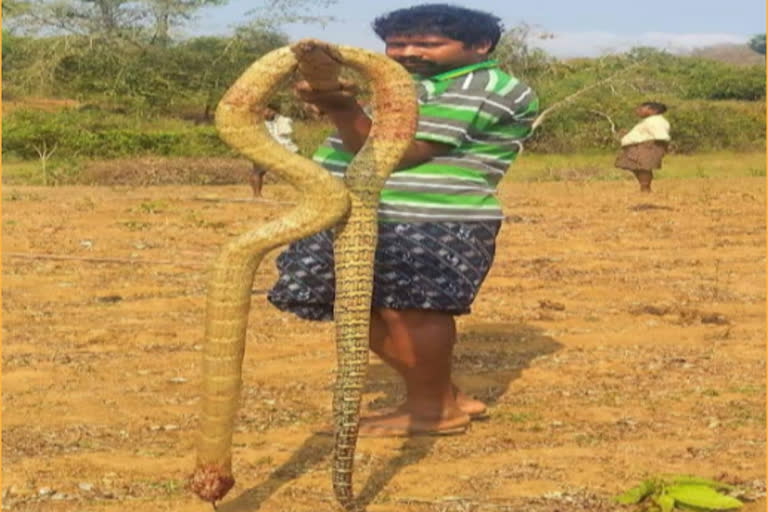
[267,221,501,320]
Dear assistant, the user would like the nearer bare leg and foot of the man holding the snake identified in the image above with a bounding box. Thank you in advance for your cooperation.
[360,308,469,434]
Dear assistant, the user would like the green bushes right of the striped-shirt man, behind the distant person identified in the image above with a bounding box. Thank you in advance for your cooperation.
[502,48,766,153]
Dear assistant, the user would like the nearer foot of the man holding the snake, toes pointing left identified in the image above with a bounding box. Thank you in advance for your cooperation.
[359,405,470,437]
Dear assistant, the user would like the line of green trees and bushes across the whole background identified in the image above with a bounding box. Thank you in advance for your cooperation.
[2,0,765,162]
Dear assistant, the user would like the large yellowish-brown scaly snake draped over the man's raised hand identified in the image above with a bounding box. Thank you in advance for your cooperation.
[190,40,417,512]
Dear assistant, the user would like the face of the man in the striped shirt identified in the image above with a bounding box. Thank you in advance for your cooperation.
[386,34,490,76]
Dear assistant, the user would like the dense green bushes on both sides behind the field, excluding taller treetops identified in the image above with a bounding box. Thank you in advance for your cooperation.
[2,39,765,159]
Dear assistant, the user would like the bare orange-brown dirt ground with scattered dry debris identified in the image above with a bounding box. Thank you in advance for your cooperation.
[2,177,766,512]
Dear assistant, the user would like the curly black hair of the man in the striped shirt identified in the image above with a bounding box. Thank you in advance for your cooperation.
[372,4,504,53]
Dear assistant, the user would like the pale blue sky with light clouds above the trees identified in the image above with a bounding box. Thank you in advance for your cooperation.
[187,0,766,57]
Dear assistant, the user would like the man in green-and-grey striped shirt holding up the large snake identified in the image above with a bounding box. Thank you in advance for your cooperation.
[268,4,538,436]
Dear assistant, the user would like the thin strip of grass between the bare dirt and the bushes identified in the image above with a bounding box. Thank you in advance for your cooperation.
[2,149,766,186]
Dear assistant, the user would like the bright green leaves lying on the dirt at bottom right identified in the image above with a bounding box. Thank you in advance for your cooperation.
[615,475,742,512]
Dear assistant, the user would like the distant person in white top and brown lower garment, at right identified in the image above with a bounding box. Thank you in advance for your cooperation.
[614,101,669,192]
